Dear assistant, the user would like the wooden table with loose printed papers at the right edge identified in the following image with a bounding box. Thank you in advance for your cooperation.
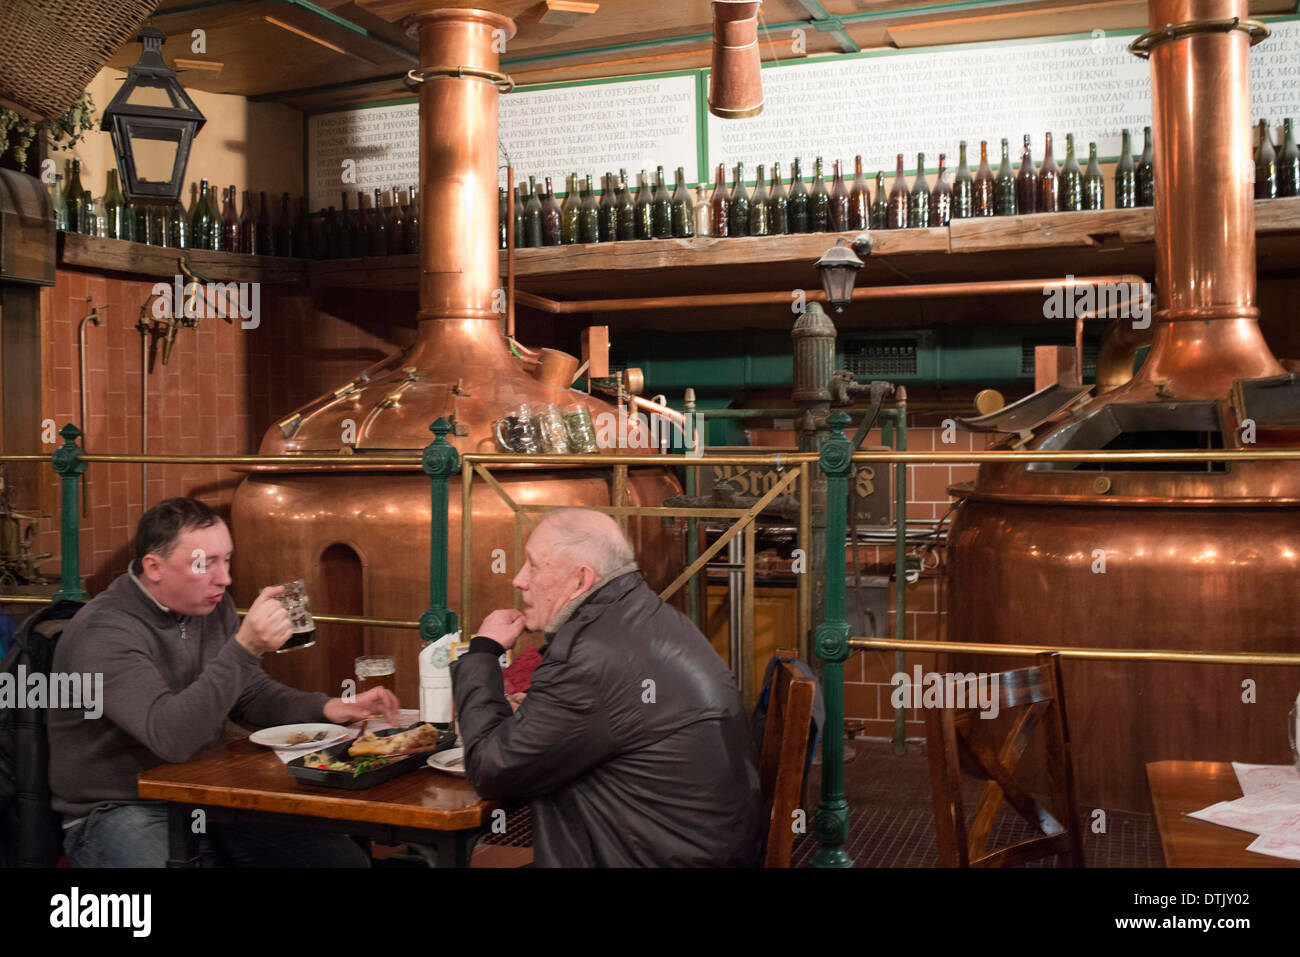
[1147,761,1300,867]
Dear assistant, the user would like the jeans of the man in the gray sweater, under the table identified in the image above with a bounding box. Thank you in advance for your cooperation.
[64,804,371,867]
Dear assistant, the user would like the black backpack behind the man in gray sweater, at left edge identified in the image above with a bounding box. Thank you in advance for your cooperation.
[0,601,82,867]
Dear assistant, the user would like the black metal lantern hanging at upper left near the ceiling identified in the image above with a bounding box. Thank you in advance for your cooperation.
[103,26,204,203]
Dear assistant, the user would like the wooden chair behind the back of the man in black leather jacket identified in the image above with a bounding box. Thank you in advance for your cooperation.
[758,648,816,867]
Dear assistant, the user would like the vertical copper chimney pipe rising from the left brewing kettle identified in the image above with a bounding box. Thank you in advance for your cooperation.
[411,9,515,320]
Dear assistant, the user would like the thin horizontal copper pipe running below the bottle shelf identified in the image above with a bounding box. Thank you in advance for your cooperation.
[515,276,1144,316]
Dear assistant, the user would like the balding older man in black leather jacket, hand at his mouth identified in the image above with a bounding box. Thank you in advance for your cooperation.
[451,508,763,867]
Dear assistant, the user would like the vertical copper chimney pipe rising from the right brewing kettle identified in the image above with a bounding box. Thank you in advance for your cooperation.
[1132,0,1283,398]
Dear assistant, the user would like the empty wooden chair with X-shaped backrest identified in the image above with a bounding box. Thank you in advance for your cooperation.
[926,653,1084,867]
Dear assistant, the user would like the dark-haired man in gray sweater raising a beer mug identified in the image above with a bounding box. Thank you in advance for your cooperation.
[48,498,398,867]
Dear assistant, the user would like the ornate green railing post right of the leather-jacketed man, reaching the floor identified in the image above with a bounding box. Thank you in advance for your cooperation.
[813,411,853,867]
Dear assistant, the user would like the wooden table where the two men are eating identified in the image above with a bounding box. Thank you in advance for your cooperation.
[139,739,497,867]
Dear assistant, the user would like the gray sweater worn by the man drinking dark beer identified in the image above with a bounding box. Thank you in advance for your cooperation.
[48,573,329,818]
